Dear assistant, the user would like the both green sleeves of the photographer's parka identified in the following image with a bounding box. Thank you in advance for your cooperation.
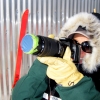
[12,60,100,100]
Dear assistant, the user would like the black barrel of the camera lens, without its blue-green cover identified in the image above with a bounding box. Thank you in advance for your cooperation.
[34,36,64,57]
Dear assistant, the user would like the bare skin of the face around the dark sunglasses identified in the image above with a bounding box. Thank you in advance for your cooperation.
[73,33,89,63]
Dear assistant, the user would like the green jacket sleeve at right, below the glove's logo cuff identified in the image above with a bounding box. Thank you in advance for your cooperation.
[56,76,100,100]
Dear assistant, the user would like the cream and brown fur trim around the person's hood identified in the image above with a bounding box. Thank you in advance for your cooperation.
[58,12,100,73]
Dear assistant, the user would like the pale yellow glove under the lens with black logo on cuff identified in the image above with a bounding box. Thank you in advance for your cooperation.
[38,47,83,87]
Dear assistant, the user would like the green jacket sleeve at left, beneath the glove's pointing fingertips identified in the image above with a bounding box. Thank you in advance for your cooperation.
[12,60,47,100]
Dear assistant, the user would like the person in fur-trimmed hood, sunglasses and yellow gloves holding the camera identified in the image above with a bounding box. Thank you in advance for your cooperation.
[12,12,100,100]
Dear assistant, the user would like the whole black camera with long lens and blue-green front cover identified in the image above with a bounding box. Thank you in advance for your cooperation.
[21,34,80,63]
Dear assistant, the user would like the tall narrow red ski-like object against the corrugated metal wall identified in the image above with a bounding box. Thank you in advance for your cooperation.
[12,9,29,88]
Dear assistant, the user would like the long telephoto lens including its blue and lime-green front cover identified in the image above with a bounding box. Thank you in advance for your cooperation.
[21,34,65,57]
